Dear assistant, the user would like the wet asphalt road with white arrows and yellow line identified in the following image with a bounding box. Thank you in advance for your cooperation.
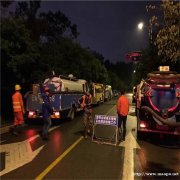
[0,94,180,180]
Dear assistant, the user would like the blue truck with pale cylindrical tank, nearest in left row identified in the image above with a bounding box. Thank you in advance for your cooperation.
[26,75,88,120]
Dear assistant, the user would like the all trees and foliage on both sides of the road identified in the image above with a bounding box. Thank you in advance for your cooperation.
[0,1,180,121]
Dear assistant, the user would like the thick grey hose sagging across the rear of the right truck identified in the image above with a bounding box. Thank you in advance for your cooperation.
[141,106,180,127]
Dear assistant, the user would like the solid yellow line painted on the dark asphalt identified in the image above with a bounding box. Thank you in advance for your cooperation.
[35,136,84,180]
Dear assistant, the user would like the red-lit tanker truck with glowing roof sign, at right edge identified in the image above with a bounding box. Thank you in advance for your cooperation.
[136,67,180,139]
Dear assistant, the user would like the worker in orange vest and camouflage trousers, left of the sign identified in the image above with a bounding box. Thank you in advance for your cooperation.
[79,92,93,139]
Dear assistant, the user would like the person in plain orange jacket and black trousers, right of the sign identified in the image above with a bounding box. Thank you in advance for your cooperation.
[117,90,129,141]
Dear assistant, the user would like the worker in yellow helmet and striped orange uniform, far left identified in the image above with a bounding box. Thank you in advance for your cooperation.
[10,84,25,135]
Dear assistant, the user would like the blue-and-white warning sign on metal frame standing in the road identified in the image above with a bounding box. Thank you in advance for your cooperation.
[92,115,120,145]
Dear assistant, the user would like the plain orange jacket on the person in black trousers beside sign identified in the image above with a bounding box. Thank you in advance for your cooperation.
[117,95,129,116]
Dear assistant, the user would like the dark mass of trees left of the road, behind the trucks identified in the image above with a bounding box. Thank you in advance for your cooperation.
[1,1,132,121]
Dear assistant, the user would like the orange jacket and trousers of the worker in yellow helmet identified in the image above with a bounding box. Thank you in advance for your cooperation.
[12,91,24,126]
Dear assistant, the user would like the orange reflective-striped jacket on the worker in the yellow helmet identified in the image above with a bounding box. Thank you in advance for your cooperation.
[12,91,24,112]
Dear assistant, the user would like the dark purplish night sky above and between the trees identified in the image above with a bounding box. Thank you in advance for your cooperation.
[9,1,160,63]
